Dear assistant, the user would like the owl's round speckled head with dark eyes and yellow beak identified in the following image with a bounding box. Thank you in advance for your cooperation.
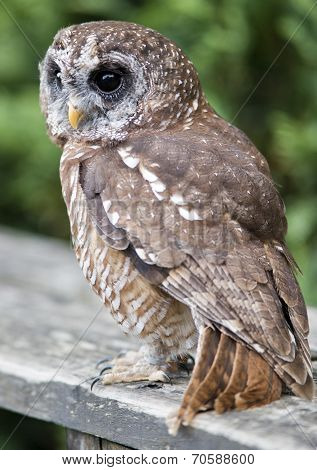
[40,21,203,146]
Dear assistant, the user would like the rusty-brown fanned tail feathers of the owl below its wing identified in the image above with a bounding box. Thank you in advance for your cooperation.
[167,327,282,435]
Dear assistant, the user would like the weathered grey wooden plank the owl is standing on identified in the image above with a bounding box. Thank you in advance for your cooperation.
[0,229,317,449]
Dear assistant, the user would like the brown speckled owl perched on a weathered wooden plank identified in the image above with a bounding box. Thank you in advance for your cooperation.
[40,21,314,434]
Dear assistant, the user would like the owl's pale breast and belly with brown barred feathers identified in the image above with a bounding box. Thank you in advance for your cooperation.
[60,145,197,362]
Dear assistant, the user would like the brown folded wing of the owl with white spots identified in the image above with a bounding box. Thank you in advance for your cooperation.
[80,124,312,397]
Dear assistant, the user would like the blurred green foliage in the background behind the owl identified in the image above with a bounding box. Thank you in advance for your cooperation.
[0,0,317,304]
